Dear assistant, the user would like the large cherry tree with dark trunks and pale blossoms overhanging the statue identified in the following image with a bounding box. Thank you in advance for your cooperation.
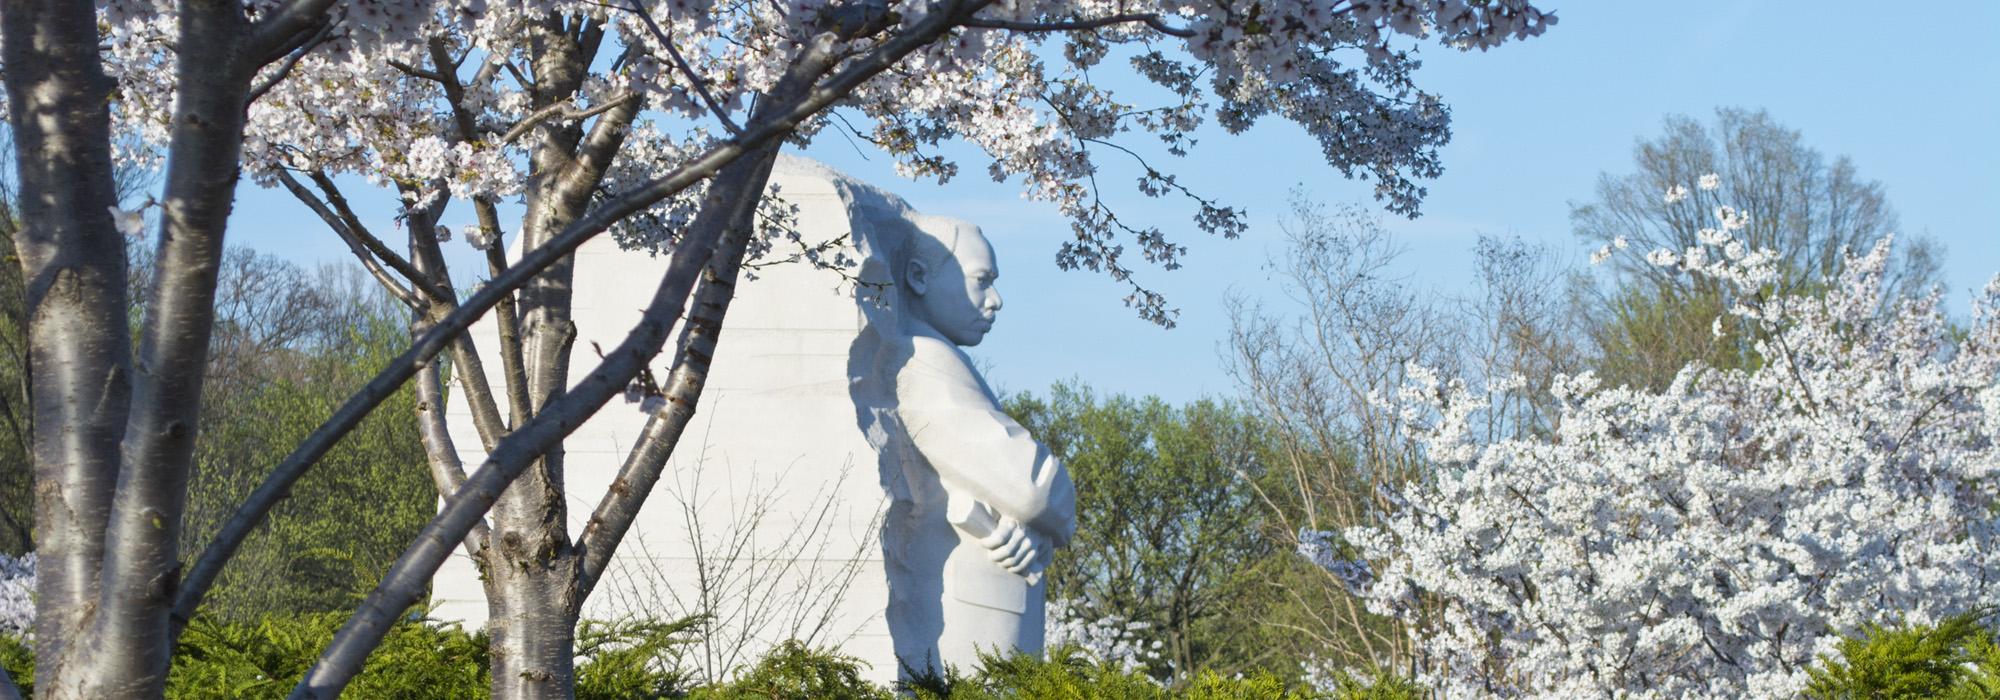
[0,0,1554,698]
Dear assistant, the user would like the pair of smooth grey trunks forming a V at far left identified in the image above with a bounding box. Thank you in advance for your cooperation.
[0,0,328,698]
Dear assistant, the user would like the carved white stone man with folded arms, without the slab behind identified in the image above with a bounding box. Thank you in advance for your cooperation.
[842,180,1076,676]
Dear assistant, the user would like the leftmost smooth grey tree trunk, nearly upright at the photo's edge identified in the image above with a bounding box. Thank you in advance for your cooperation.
[0,0,132,680]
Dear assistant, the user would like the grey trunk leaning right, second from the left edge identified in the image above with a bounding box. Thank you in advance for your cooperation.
[77,2,258,698]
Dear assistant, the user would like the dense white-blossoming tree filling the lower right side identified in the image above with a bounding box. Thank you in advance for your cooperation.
[1328,200,2000,698]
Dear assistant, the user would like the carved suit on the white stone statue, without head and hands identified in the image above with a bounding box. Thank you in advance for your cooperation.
[882,336,1076,670]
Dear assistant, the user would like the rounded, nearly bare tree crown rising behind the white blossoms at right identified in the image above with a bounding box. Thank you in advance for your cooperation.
[1570,108,1940,388]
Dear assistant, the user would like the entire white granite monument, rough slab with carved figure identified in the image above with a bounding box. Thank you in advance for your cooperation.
[434,158,1074,682]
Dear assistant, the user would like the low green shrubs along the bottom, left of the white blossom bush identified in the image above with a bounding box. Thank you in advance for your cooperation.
[0,612,1422,700]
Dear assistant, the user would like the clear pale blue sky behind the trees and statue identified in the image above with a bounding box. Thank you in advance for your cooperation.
[232,2,2000,402]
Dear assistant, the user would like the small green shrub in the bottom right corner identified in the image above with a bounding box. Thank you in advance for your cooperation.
[1806,610,2000,700]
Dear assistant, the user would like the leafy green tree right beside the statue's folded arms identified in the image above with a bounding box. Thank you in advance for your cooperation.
[1008,384,1292,680]
